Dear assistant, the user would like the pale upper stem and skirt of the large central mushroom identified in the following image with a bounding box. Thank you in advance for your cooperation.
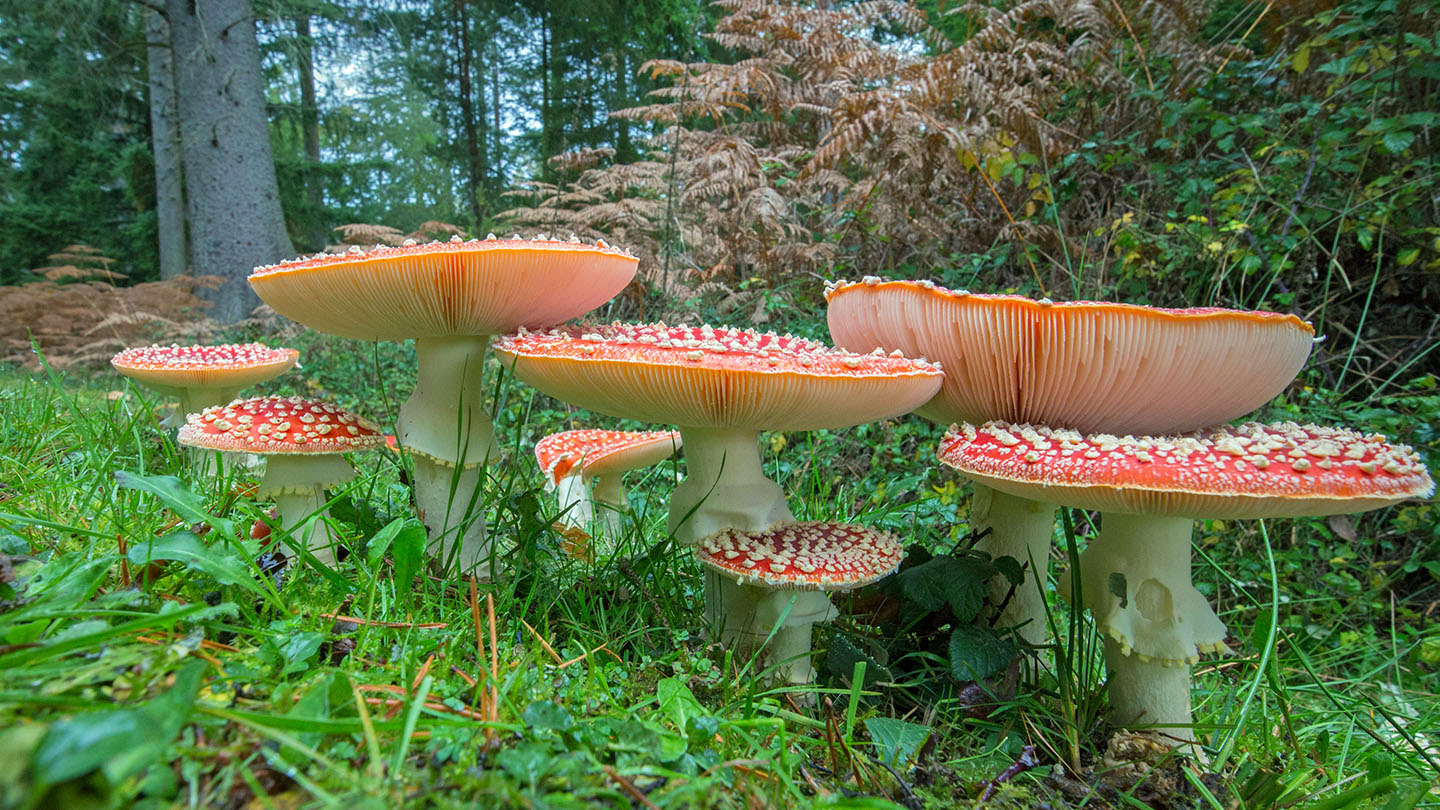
[668,427,795,546]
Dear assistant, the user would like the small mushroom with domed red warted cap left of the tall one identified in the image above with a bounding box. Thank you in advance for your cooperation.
[179,396,384,566]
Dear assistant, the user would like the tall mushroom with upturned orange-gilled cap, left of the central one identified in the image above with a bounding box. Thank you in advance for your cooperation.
[251,235,638,577]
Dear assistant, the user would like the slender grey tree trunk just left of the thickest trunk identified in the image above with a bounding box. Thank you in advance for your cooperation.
[145,10,186,278]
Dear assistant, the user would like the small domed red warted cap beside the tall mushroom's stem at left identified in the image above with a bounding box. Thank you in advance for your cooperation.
[179,396,384,455]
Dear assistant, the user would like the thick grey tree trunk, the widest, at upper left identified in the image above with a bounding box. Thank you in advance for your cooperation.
[166,0,295,323]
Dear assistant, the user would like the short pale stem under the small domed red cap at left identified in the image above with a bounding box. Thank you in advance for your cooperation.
[256,454,356,568]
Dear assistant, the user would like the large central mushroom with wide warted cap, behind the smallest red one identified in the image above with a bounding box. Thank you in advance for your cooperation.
[495,323,943,657]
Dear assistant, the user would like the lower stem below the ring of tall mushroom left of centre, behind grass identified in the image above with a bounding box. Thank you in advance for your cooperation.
[412,453,500,582]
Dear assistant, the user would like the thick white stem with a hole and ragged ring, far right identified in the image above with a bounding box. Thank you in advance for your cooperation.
[1080,513,1225,739]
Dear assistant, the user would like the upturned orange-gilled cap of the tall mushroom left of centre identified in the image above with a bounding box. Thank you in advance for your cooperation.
[251,236,638,340]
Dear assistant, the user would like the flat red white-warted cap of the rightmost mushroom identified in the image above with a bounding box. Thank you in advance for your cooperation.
[939,422,1434,519]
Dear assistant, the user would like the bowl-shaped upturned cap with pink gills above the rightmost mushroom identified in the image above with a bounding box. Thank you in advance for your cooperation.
[825,277,1315,435]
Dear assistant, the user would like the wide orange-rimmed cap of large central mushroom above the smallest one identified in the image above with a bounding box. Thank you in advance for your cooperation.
[494,323,943,430]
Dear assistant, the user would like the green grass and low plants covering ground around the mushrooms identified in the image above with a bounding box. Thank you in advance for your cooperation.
[0,343,1440,810]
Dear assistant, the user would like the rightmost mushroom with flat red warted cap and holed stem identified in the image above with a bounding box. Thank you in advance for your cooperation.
[939,422,1434,735]
